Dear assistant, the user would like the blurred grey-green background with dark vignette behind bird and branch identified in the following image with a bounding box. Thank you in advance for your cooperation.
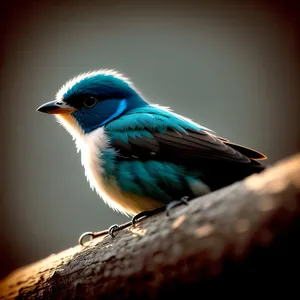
[0,0,300,277]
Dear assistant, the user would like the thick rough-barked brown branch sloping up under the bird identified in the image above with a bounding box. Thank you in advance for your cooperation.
[0,154,300,299]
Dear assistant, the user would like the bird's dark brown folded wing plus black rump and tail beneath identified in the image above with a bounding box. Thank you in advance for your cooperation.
[111,130,265,190]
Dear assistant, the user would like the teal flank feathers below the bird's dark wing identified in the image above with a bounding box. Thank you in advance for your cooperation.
[102,149,201,203]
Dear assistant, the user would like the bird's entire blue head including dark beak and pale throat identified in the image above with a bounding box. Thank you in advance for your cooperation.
[37,70,148,138]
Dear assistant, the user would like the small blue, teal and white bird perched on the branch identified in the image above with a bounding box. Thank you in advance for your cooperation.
[37,69,267,236]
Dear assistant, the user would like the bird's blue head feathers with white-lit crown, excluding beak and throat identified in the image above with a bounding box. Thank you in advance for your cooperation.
[59,70,147,132]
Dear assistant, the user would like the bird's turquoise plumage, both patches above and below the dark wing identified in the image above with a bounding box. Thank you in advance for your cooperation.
[101,106,203,203]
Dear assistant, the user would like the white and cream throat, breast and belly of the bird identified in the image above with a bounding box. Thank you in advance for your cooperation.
[56,115,162,216]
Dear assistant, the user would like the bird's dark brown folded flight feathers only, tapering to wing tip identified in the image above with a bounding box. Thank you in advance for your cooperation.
[113,130,265,165]
